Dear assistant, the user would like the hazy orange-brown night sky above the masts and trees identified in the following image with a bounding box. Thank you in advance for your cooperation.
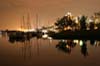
[0,0,100,30]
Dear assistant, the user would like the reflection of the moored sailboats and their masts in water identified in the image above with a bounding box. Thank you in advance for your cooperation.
[8,36,33,59]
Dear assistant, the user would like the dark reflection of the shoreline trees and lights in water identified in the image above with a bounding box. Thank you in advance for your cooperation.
[56,40,100,57]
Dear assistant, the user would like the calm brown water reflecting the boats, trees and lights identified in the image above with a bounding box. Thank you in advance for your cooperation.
[0,35,100,66]
